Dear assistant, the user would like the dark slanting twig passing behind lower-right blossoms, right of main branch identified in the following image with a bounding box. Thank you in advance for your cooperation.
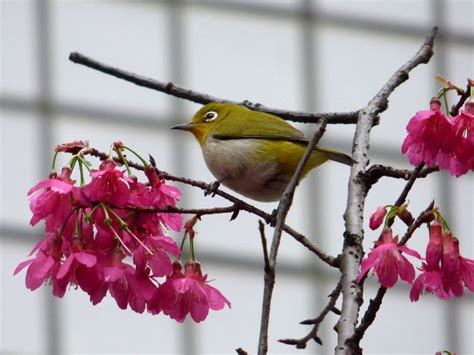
[349,201,434,353]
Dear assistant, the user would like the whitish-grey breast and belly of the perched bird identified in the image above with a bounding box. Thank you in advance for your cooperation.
[203,136,291,201]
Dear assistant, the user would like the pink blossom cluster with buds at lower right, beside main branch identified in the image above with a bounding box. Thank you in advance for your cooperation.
[358,206,474,301]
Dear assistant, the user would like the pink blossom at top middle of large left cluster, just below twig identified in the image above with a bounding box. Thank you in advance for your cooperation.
[83,159,130,207]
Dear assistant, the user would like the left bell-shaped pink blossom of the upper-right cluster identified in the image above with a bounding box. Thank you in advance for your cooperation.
[402,100,456,166]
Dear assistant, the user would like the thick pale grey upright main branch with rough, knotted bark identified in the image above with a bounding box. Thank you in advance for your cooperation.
[336,27,438,355]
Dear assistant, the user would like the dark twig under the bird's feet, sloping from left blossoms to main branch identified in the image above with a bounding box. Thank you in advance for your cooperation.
[80,148,339,268]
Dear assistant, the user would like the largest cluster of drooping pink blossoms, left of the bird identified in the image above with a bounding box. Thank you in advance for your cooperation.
[15,141,230,322]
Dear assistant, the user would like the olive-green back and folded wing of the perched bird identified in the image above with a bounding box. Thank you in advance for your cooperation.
[212,108,308,144]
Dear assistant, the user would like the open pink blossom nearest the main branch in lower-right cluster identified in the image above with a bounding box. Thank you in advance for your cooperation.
[357,228,421,288]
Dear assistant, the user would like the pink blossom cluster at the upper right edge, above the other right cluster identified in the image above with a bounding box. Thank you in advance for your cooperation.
[402,81,474,176]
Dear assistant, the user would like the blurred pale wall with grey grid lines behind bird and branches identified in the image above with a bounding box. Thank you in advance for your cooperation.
[0,0,474,355]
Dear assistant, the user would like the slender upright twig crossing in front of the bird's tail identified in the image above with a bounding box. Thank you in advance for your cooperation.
[258,120,327,355]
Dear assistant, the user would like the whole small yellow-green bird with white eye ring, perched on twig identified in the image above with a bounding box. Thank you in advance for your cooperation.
[175,103,352,201]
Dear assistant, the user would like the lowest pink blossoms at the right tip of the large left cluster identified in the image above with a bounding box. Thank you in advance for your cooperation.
[148,262,230,323]
